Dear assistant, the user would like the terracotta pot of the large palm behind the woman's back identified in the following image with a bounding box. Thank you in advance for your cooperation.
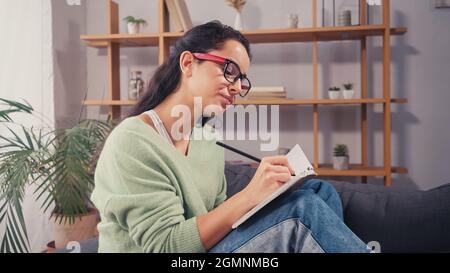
[52,209,98,248]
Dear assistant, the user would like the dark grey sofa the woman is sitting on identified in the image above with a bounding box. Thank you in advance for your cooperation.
[57,164,450,253]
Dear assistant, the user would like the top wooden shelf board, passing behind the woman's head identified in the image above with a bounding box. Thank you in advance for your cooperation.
[80,25,407,48]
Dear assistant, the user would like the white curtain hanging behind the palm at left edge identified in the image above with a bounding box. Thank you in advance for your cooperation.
[0,0,55,252]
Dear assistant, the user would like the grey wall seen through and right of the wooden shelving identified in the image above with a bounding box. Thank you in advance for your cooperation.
[83,0,450,189]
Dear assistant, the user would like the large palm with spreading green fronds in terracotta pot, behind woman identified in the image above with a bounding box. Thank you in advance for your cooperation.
[0,99,112,252]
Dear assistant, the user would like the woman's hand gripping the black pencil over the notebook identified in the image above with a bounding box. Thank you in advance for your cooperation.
[242,156,294,206]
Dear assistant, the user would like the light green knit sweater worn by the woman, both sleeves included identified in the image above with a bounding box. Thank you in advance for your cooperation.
[92,117,226,252]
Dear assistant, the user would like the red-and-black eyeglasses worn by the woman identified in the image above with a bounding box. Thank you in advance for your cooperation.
[193,53,252,97]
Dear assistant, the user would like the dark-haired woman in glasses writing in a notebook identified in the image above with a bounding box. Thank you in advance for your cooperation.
[92,21,367,252]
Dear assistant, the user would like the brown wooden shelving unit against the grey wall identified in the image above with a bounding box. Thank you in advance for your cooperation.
[81,0,407,186]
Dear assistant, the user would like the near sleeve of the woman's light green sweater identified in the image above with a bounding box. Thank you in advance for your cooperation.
[96,130,205,253]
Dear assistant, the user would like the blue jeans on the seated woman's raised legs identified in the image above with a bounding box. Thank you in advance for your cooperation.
[209,179,370,253]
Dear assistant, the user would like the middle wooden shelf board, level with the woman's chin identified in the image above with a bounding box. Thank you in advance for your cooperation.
[83,99,408,106]
